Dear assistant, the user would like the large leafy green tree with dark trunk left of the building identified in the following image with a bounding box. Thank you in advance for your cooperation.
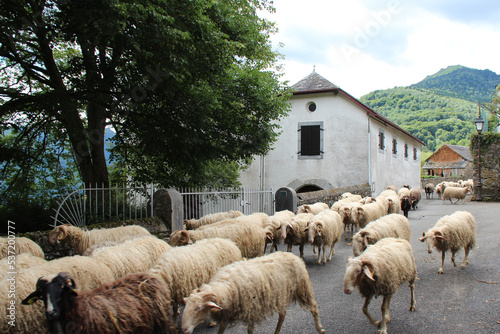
[0,0,287,186]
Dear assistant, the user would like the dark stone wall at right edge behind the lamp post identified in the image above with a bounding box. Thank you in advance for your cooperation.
[471,133,500,201]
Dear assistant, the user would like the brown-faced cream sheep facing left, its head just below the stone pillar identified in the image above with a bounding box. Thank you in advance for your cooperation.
[169,223,266,258]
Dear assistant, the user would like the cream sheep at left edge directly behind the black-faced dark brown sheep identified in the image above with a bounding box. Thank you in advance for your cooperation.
[0,255,114,333]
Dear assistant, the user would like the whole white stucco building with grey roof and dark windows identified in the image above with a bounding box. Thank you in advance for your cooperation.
[240,71,424,196]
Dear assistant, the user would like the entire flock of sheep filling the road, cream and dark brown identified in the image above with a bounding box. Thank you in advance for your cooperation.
[0,184,476,334]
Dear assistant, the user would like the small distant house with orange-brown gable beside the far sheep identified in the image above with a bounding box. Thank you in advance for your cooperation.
[422,144,472,177]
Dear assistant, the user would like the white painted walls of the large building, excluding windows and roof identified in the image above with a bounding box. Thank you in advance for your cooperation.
[240,92,420,195]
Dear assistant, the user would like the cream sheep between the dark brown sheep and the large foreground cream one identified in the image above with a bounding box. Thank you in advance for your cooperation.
[149,238,242,318]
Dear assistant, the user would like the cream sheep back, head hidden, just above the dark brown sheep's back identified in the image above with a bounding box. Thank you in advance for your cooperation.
[92,235,172,278]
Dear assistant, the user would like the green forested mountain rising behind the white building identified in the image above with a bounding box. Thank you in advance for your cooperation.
[360,66,500,151]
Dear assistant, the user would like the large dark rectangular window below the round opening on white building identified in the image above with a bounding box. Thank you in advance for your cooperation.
[298,122,324,159]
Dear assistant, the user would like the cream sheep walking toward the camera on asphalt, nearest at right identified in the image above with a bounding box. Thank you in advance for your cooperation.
[344,238,417,334]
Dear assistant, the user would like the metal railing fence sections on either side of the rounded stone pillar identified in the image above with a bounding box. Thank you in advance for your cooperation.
[52,184,274,227]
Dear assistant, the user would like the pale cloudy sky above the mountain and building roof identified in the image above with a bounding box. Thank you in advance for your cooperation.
[266,0,500,98]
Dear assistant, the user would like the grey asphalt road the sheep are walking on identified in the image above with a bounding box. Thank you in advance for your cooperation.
[181,196,500,334]
